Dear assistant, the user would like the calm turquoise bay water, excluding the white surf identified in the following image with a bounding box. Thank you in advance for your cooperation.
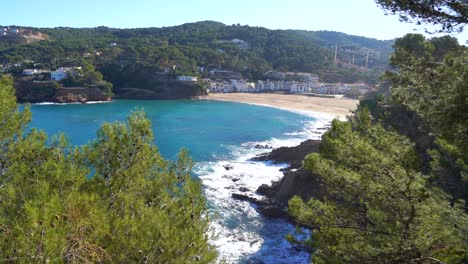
[32,100,310,161]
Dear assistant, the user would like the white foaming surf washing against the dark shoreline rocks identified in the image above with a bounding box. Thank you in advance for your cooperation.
[195,113,331,264]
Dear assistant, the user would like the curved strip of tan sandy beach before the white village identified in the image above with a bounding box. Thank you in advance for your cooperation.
[200,93,359,120]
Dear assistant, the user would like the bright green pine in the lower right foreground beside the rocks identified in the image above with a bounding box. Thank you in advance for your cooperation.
[289,110,468,263]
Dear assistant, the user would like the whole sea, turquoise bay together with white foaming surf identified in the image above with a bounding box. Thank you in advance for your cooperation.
[31,100,330,264]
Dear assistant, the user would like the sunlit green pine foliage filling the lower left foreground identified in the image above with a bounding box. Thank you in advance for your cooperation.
[0,76,216,263]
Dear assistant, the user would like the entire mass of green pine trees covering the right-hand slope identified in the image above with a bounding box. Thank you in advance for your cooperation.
[289,34,468,264]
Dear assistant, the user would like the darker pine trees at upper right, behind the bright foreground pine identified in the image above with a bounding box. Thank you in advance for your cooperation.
[385,35,468,199]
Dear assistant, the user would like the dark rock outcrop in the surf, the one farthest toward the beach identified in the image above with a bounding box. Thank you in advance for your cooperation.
[252,139,320,169]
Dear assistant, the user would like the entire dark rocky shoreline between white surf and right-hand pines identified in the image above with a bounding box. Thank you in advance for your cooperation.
[230,139,323,224]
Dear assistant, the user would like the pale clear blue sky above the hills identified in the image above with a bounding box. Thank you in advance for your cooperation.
[0,0,468,43]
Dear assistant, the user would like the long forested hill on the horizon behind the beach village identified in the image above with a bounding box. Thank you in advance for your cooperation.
[0,21,393,86]
